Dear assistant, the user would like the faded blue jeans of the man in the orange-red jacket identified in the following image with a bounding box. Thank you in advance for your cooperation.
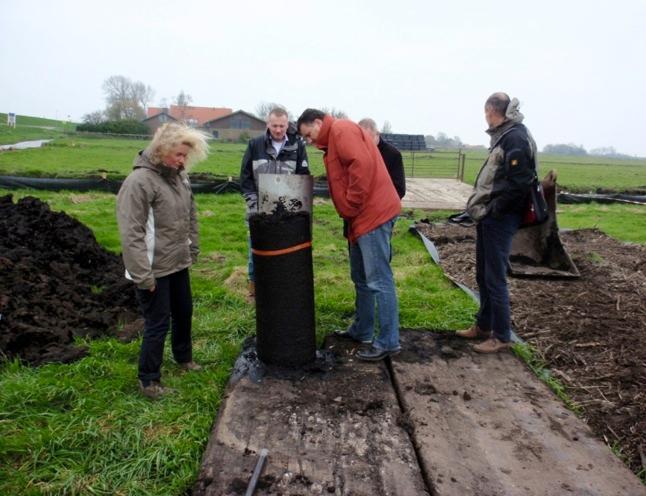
[348,217,399,351]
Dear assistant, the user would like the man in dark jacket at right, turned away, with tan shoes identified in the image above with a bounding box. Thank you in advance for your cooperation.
[457,93,537,353]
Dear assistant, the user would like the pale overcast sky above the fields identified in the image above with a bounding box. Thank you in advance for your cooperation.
[0,0,646,156]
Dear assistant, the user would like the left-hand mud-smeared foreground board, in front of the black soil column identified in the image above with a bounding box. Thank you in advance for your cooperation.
[193,337,428,496]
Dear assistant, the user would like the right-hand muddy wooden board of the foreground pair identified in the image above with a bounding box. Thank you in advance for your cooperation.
[393,332,646,496]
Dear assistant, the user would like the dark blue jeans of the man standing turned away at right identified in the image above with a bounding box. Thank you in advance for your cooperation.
[476,213,521,342]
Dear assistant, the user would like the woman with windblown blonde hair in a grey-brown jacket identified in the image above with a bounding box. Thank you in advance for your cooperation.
[117,123,209,398]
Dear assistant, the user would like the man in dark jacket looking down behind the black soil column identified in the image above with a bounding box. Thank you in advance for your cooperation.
[240,107,310,297]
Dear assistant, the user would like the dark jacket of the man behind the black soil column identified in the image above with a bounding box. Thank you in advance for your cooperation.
[240,130,310,210]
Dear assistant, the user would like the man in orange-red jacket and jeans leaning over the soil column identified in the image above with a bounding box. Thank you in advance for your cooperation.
[296,109,401,361]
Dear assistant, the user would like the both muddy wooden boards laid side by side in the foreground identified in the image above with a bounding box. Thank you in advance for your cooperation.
[193,331,646,496]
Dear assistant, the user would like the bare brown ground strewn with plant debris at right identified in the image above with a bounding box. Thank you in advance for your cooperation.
[418,223,646,472]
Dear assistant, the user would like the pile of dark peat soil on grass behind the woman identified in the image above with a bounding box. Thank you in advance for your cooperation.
[0,195,137,365]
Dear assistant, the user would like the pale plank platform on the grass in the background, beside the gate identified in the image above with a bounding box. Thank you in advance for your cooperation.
[402,177,473,210]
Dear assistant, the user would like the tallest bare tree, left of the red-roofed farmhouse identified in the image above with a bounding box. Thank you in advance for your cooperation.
[103,76,154,121]
